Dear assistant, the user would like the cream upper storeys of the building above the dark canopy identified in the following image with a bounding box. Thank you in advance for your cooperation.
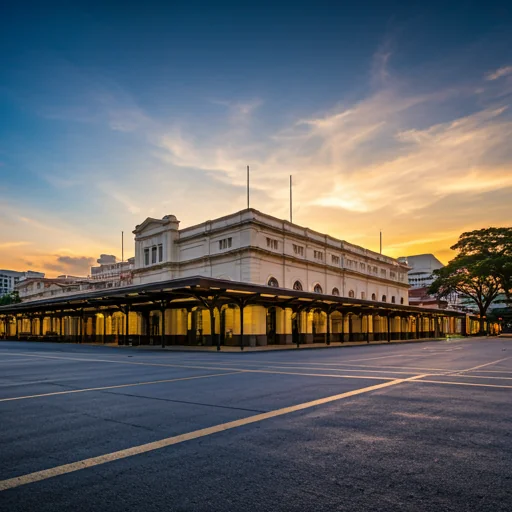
[133,209,409,305]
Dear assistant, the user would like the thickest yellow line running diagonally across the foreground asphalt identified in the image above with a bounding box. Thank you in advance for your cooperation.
[0,375,425,491]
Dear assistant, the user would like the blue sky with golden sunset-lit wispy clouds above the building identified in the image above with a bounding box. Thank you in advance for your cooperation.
[0,0,512,277]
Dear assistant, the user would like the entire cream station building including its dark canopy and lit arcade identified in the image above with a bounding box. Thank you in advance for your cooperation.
[0,209,467,348]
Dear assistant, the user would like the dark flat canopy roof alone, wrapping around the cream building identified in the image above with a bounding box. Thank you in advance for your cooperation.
[0,276,464,316]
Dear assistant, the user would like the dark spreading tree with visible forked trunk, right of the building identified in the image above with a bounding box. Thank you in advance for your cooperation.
[428,254,500,332]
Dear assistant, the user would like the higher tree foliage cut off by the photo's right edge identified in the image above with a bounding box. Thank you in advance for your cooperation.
[452,228,512,304]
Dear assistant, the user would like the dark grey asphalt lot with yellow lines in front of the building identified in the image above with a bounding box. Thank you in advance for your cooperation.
[0,338,512,512]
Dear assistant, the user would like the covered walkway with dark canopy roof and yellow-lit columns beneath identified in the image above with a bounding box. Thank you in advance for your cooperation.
[0,276,466,350]
